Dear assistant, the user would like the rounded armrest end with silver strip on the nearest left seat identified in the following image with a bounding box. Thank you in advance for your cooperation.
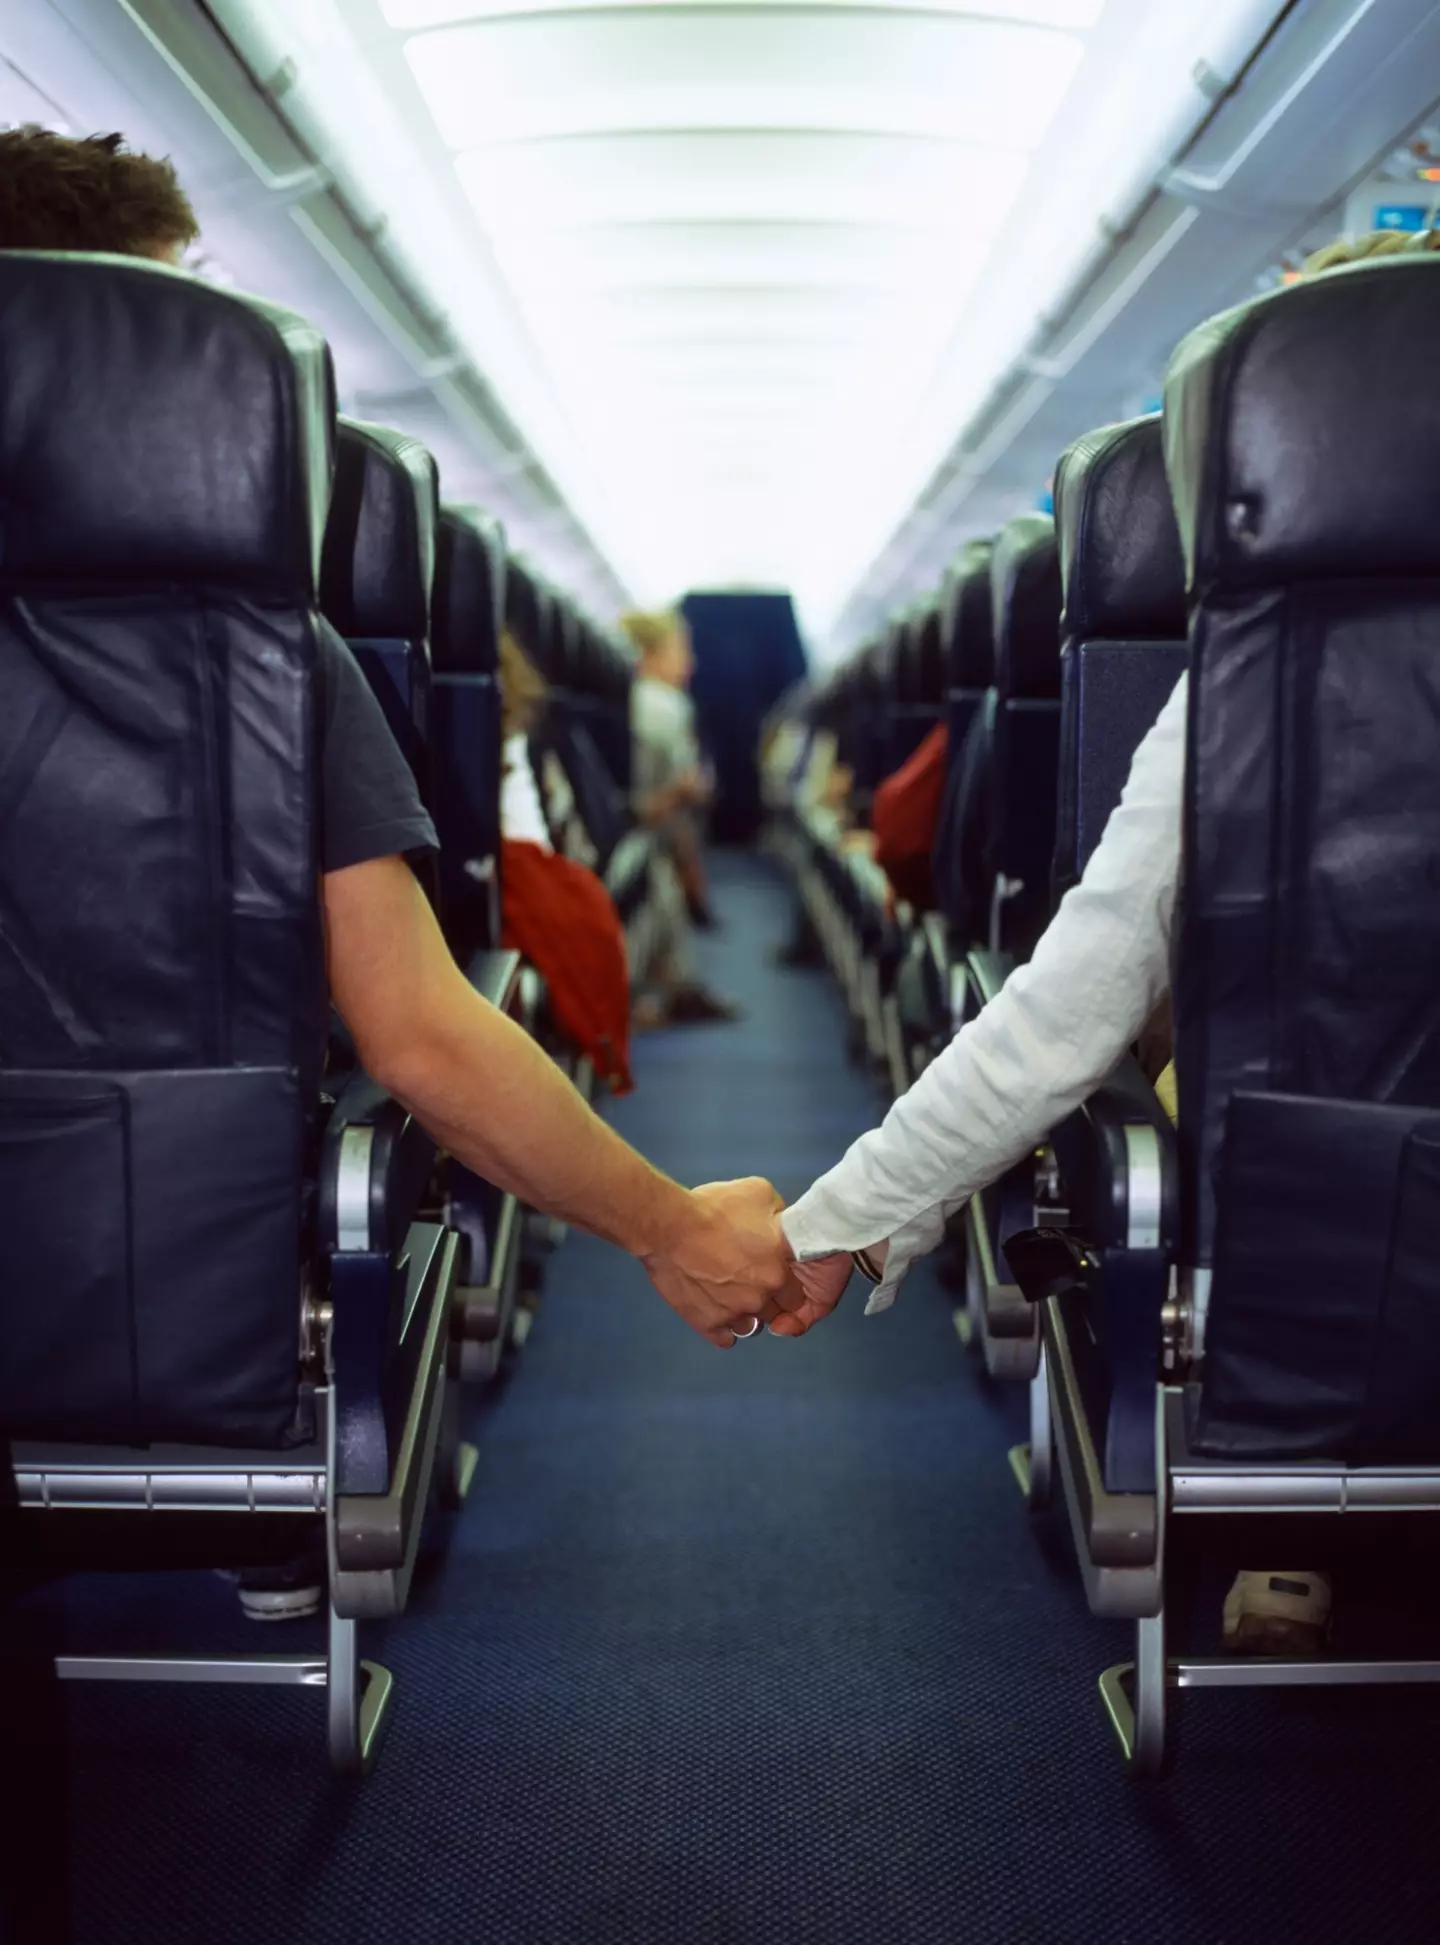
[317,1068,436,1255]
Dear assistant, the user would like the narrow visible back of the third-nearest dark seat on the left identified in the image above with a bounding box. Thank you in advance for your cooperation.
[430,506,506,963]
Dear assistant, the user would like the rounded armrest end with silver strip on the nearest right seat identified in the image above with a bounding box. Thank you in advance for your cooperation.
[1053,1054,1179,1256]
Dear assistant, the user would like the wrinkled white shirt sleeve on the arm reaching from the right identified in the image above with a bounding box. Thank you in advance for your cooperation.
[780,677,1189,1311]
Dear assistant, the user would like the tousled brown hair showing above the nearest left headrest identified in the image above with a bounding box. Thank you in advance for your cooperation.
[0,124,200,257]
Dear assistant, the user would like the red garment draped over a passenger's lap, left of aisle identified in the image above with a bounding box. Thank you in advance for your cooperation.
[500,838,634,1093]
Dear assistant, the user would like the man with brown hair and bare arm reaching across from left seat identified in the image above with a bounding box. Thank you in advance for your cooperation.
[0,126,798,1348]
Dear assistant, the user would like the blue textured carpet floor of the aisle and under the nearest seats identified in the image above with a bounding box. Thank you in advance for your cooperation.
[6,860,1440,1945]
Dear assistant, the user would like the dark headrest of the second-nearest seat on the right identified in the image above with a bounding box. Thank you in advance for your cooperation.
[1055,412,1185,642]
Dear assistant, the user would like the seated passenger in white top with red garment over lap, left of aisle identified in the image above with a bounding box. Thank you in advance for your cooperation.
[500,628,634,1093]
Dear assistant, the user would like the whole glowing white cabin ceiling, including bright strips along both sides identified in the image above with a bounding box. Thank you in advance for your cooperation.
[199,0,1273,632]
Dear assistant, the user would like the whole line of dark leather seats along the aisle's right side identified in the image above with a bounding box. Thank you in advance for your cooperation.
[776,259,1440,1772]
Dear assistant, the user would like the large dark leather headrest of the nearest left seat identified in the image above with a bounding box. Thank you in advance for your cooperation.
[0,251,335,605]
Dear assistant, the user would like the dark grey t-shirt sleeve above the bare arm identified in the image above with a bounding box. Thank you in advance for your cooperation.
[317,622,440,871]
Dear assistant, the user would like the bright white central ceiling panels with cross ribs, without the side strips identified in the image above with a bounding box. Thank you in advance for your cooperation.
[371,0,1115,597]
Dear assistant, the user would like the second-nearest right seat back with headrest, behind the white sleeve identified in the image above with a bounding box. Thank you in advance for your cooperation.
[1053,414,1189,904]
